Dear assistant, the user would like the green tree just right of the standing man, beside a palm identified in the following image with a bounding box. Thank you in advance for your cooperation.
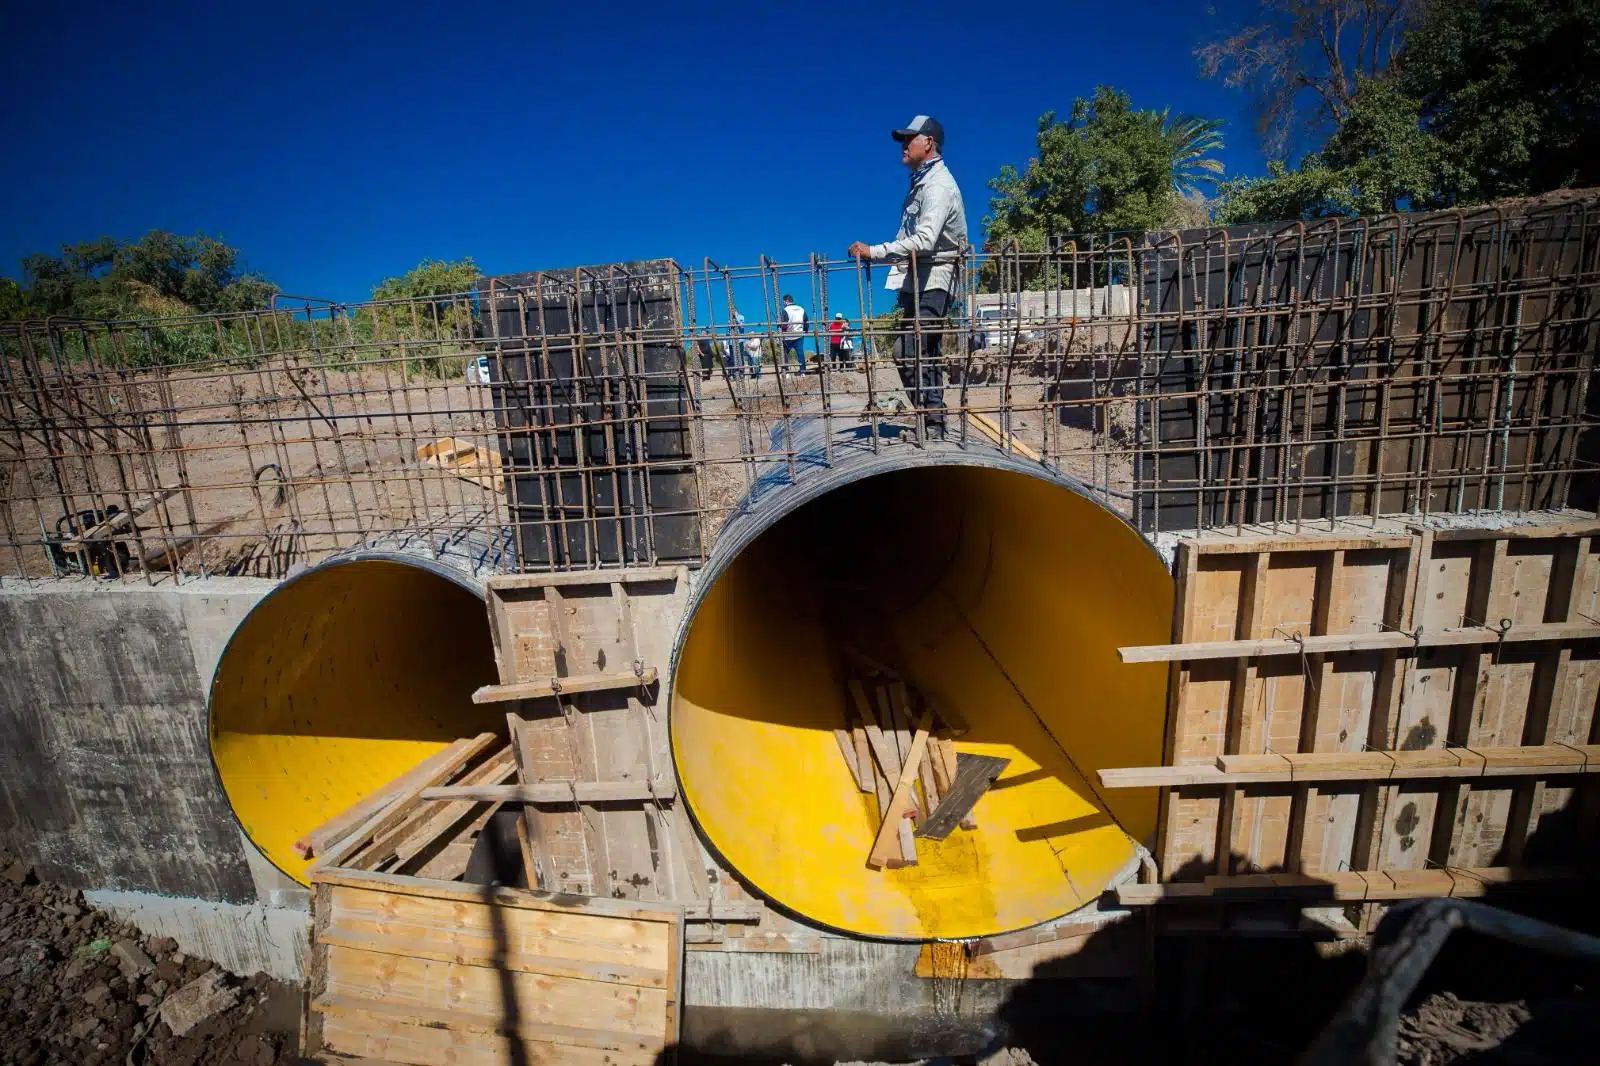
[984,85,1222,265]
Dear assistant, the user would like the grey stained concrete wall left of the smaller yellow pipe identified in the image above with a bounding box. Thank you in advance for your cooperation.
[0,578,306,978]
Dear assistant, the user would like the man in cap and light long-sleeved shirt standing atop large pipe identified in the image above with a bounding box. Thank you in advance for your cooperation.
[848,115,966,439]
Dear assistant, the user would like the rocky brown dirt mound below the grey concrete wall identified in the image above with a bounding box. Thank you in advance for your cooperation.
[0,852,298,1066]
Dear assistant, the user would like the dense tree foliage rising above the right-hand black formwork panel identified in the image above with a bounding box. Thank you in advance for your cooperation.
[1216,0,1600,222]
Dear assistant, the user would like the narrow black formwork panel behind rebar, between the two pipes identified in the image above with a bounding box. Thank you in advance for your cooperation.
[478,259,702,570]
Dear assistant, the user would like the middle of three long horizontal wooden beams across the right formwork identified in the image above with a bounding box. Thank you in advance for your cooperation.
[1099,744,1600,789]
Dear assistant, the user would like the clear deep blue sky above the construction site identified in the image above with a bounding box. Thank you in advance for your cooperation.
[0,0,1262,307]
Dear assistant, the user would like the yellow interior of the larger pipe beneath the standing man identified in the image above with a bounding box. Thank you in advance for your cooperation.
[670,467,1173,940]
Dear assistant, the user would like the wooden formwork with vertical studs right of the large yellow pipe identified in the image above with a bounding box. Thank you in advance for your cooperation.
[1157,523,1600,882]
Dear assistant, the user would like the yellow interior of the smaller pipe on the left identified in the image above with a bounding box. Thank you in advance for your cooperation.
[210,559,504,882]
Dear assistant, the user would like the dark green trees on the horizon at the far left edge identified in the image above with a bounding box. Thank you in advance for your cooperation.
[0,229,275,319]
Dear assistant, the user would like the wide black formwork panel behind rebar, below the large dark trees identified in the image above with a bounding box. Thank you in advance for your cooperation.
[1136,200,1600,531]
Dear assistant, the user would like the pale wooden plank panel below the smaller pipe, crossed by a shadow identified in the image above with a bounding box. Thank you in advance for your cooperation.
[302,869,683,1066]
